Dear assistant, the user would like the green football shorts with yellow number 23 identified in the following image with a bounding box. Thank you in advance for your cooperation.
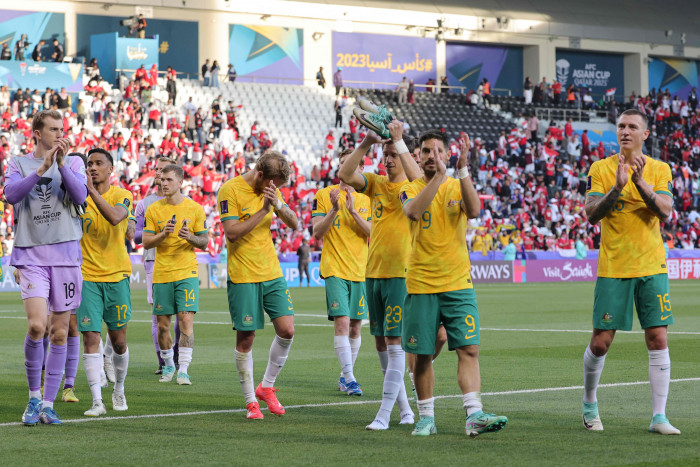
[365,277,406,337]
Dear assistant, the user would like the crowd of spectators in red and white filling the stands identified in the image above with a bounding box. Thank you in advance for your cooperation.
[0,72,700,266]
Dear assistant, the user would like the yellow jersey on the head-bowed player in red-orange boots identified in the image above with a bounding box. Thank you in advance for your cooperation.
[218,177,284,284]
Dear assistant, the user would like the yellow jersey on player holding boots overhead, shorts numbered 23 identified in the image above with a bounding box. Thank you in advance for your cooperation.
[360,173,411,279]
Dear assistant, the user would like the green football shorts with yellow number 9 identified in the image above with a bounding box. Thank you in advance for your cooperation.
[401,289,480,355]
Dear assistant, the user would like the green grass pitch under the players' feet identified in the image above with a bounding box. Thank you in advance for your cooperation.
[0,281,700,465]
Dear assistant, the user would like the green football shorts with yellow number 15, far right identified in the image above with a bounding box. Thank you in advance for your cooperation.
[593,274,673,331]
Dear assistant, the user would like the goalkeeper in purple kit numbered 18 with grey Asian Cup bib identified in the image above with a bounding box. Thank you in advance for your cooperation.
[5,110,87,425]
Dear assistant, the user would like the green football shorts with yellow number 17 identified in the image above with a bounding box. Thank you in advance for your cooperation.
[75,278,131,332]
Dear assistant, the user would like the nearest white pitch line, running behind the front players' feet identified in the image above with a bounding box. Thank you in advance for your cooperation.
[0,377,700,427]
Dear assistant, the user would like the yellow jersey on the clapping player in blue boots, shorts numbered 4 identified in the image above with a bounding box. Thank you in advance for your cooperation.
[311,185,372,282]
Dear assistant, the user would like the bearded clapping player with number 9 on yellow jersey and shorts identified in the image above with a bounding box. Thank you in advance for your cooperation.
[400,130,508,437]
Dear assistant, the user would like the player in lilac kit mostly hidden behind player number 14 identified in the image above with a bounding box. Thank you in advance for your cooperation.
[134,156,180,375]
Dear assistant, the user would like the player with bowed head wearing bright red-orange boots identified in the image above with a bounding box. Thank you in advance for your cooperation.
[218,151,299,419]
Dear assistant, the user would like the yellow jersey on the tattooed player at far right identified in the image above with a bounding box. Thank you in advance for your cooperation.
[586,154,673,279]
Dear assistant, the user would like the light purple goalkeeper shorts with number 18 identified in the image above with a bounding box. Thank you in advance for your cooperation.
[17,266,83,313]
